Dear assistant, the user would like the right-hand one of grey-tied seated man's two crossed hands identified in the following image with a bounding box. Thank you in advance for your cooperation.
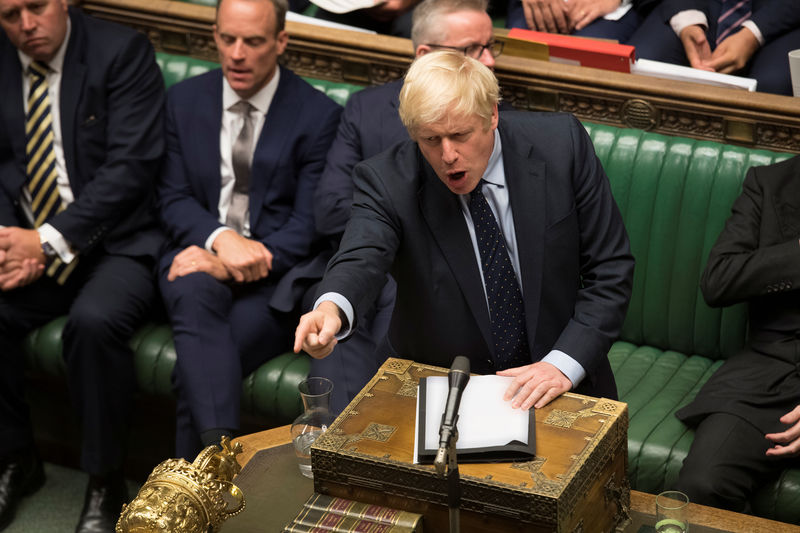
[211,230,272,283]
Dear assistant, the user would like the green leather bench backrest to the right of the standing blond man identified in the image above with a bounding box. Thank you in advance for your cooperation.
[584,123,790,359]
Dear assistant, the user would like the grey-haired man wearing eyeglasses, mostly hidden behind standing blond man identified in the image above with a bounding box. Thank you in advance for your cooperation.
[311,0,511,412]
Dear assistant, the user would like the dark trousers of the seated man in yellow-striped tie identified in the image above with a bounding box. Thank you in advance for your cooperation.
[0,255,155,475]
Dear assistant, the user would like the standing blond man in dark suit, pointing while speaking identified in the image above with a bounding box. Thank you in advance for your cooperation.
[294,51,633,409]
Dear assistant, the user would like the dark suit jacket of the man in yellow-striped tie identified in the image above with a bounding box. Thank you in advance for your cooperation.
[0,8,164,258]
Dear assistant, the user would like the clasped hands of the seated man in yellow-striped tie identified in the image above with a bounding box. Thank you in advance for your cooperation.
[0,227,45,291]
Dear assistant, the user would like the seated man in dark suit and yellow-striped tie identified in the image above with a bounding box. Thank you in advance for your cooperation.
[0,0,164,532]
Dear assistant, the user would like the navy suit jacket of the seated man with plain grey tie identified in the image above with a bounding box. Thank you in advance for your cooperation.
[159,68,341,310]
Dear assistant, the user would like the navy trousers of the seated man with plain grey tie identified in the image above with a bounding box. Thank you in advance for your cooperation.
[159,252,295,459]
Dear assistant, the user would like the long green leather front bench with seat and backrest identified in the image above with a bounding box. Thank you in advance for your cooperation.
[27,47,800,524]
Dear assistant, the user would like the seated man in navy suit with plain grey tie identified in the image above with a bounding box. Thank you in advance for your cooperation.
[159,0,341,458]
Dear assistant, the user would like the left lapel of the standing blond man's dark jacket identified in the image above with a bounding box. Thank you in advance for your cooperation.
[419,155,494,352]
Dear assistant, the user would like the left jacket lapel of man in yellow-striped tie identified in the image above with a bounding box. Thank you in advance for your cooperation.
[0,48,25,198]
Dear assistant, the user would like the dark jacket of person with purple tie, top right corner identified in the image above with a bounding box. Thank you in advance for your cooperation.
[663,0,800,42]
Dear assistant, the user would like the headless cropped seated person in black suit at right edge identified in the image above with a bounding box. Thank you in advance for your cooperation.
[675,157,800,512]
